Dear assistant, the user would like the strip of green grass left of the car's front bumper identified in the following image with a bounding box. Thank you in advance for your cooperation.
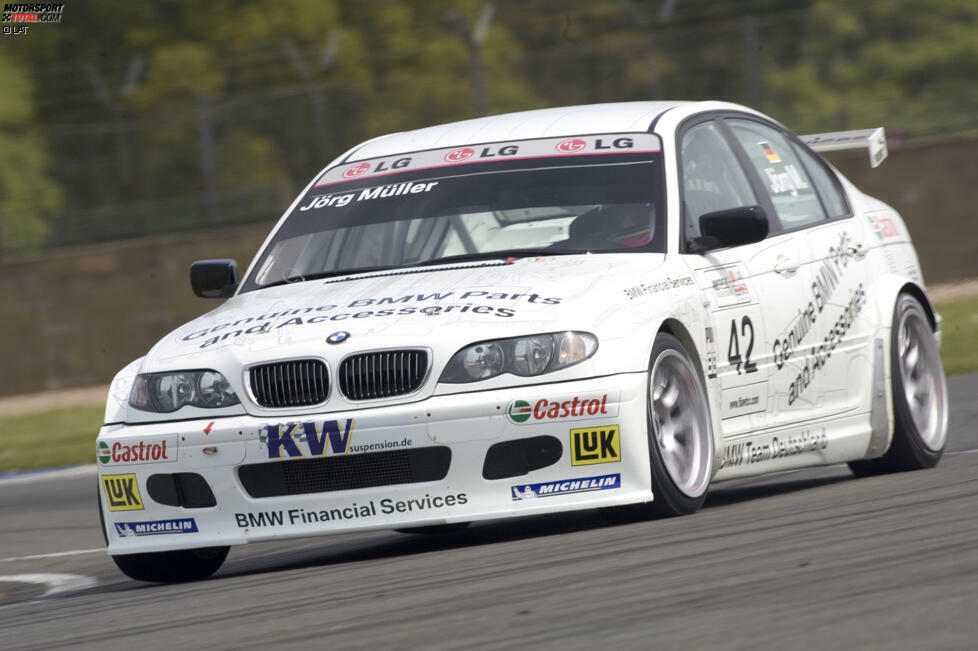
[0,407,105,472]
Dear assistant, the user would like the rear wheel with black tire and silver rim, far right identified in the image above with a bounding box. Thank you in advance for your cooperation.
[849,293,948,476]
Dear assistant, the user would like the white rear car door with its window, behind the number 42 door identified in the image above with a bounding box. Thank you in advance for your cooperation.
[724,117,872,417]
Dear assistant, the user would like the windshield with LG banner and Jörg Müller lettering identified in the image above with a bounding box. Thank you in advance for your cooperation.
[242,133,665,291]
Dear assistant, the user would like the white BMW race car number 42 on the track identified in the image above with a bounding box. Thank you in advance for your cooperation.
[96,102,948,581]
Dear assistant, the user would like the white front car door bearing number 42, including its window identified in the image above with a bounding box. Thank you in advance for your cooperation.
[679,119,813,438]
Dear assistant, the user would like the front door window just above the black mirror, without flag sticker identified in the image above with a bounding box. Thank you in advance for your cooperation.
[681,122,757,241]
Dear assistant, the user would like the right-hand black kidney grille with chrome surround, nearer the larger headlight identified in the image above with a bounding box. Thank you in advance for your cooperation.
[339,349,428,400]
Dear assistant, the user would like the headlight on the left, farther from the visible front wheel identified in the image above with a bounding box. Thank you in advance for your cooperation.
[129,370,240,414]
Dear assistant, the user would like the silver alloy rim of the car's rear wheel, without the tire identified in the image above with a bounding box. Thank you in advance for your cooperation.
[897,309,947,451]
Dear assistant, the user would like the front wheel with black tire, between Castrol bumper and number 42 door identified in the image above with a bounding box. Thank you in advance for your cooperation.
[603,332,713,522]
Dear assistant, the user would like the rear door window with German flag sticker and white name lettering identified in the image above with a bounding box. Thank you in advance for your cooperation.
[726,119,826,230]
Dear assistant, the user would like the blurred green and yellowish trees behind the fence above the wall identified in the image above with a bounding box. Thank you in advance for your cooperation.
[0,0,978,256]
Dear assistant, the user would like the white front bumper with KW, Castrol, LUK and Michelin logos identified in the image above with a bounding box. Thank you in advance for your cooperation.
[97,373,652,554]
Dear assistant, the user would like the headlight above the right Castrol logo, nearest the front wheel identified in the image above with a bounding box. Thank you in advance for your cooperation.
[438,332,598,384]
